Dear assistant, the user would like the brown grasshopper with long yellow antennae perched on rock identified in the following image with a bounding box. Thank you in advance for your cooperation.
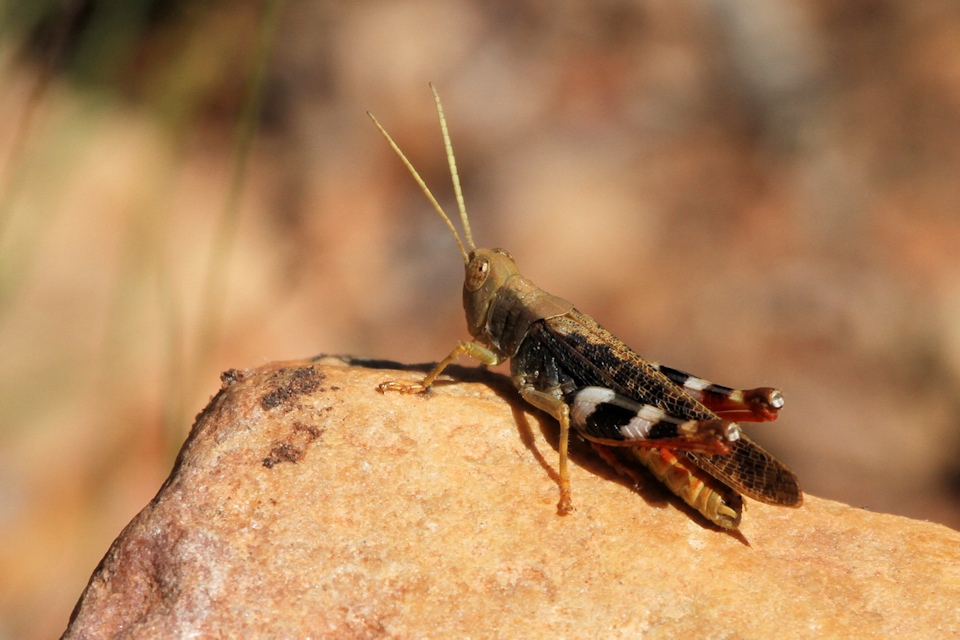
[367,84,803,529]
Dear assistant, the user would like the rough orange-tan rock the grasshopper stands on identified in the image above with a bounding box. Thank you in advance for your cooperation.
[66,361,960,638]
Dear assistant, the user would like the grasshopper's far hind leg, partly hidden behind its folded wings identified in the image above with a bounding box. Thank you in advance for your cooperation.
[651,362,783,422]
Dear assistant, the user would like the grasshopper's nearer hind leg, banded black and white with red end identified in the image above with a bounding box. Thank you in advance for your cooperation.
[570,387,740,451]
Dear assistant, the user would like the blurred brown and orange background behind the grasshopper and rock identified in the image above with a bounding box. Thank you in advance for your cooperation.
[0,0,960,639]
